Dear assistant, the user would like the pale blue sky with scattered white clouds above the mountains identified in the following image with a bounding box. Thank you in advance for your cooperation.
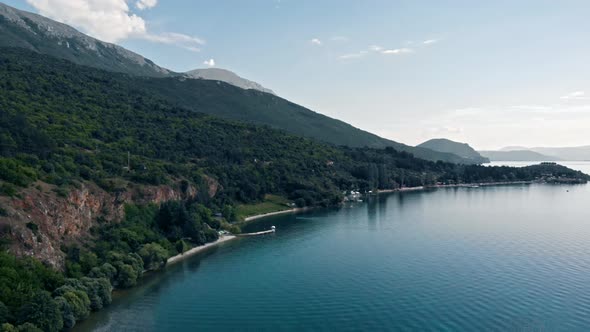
[5,0,590,150]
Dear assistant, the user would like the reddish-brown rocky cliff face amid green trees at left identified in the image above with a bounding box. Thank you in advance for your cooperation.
[0,178,219,268]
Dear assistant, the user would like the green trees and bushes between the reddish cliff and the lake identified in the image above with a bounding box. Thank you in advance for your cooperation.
[0,201,221,331]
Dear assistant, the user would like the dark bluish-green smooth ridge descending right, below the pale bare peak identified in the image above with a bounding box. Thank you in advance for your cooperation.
[136,77,473,164]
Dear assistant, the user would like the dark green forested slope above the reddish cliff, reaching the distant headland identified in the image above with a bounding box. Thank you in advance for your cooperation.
[0,49,579,205]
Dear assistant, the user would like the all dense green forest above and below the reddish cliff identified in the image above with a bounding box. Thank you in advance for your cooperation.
[0,49,587,331]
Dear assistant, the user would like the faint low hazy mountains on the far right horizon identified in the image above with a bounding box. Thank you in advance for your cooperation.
[479,146,590,161]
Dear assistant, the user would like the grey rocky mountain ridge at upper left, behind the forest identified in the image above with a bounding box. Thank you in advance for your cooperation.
[0,3,174,77]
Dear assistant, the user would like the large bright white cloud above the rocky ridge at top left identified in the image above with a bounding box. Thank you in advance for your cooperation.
[27,0,205,51]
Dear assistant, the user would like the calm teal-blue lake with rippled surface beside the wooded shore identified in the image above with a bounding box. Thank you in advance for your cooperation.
[75,162,590,332]
